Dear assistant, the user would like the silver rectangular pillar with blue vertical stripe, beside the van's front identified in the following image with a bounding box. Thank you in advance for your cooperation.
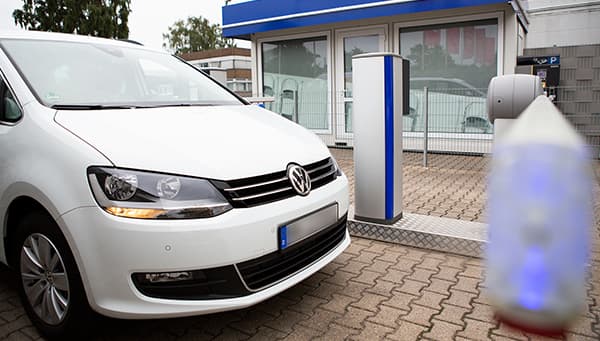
[352,53,409,224]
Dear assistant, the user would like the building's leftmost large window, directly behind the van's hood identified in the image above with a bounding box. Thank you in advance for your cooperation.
[262,37,329,129]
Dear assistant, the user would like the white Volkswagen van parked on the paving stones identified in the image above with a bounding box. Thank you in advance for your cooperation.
[0,31,350,337]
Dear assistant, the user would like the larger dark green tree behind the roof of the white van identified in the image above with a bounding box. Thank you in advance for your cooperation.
[13,0,131,39]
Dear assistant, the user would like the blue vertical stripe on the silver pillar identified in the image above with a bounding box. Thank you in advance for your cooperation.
[383,56,394,220]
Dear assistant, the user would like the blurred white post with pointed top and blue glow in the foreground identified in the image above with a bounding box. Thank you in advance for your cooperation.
[486,96,593,331]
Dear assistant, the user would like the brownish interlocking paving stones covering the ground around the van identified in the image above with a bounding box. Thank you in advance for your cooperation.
[0,155,600,341]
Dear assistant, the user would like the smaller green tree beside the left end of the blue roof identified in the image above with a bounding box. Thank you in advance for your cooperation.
[163,16,235,54]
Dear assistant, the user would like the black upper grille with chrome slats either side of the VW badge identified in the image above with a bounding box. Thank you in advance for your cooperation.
[213,158,338,208]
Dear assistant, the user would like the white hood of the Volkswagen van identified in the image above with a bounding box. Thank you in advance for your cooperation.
[55,105,330,180]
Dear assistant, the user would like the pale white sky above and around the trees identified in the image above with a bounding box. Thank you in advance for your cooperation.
[0,0,250,48]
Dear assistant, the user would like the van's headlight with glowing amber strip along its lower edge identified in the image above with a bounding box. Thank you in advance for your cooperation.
[88,167,232,219]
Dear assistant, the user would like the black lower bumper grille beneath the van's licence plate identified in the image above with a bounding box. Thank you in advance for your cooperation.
[237,216,346,290]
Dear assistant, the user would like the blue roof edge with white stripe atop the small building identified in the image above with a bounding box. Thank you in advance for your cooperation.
[223,0,523,39]
